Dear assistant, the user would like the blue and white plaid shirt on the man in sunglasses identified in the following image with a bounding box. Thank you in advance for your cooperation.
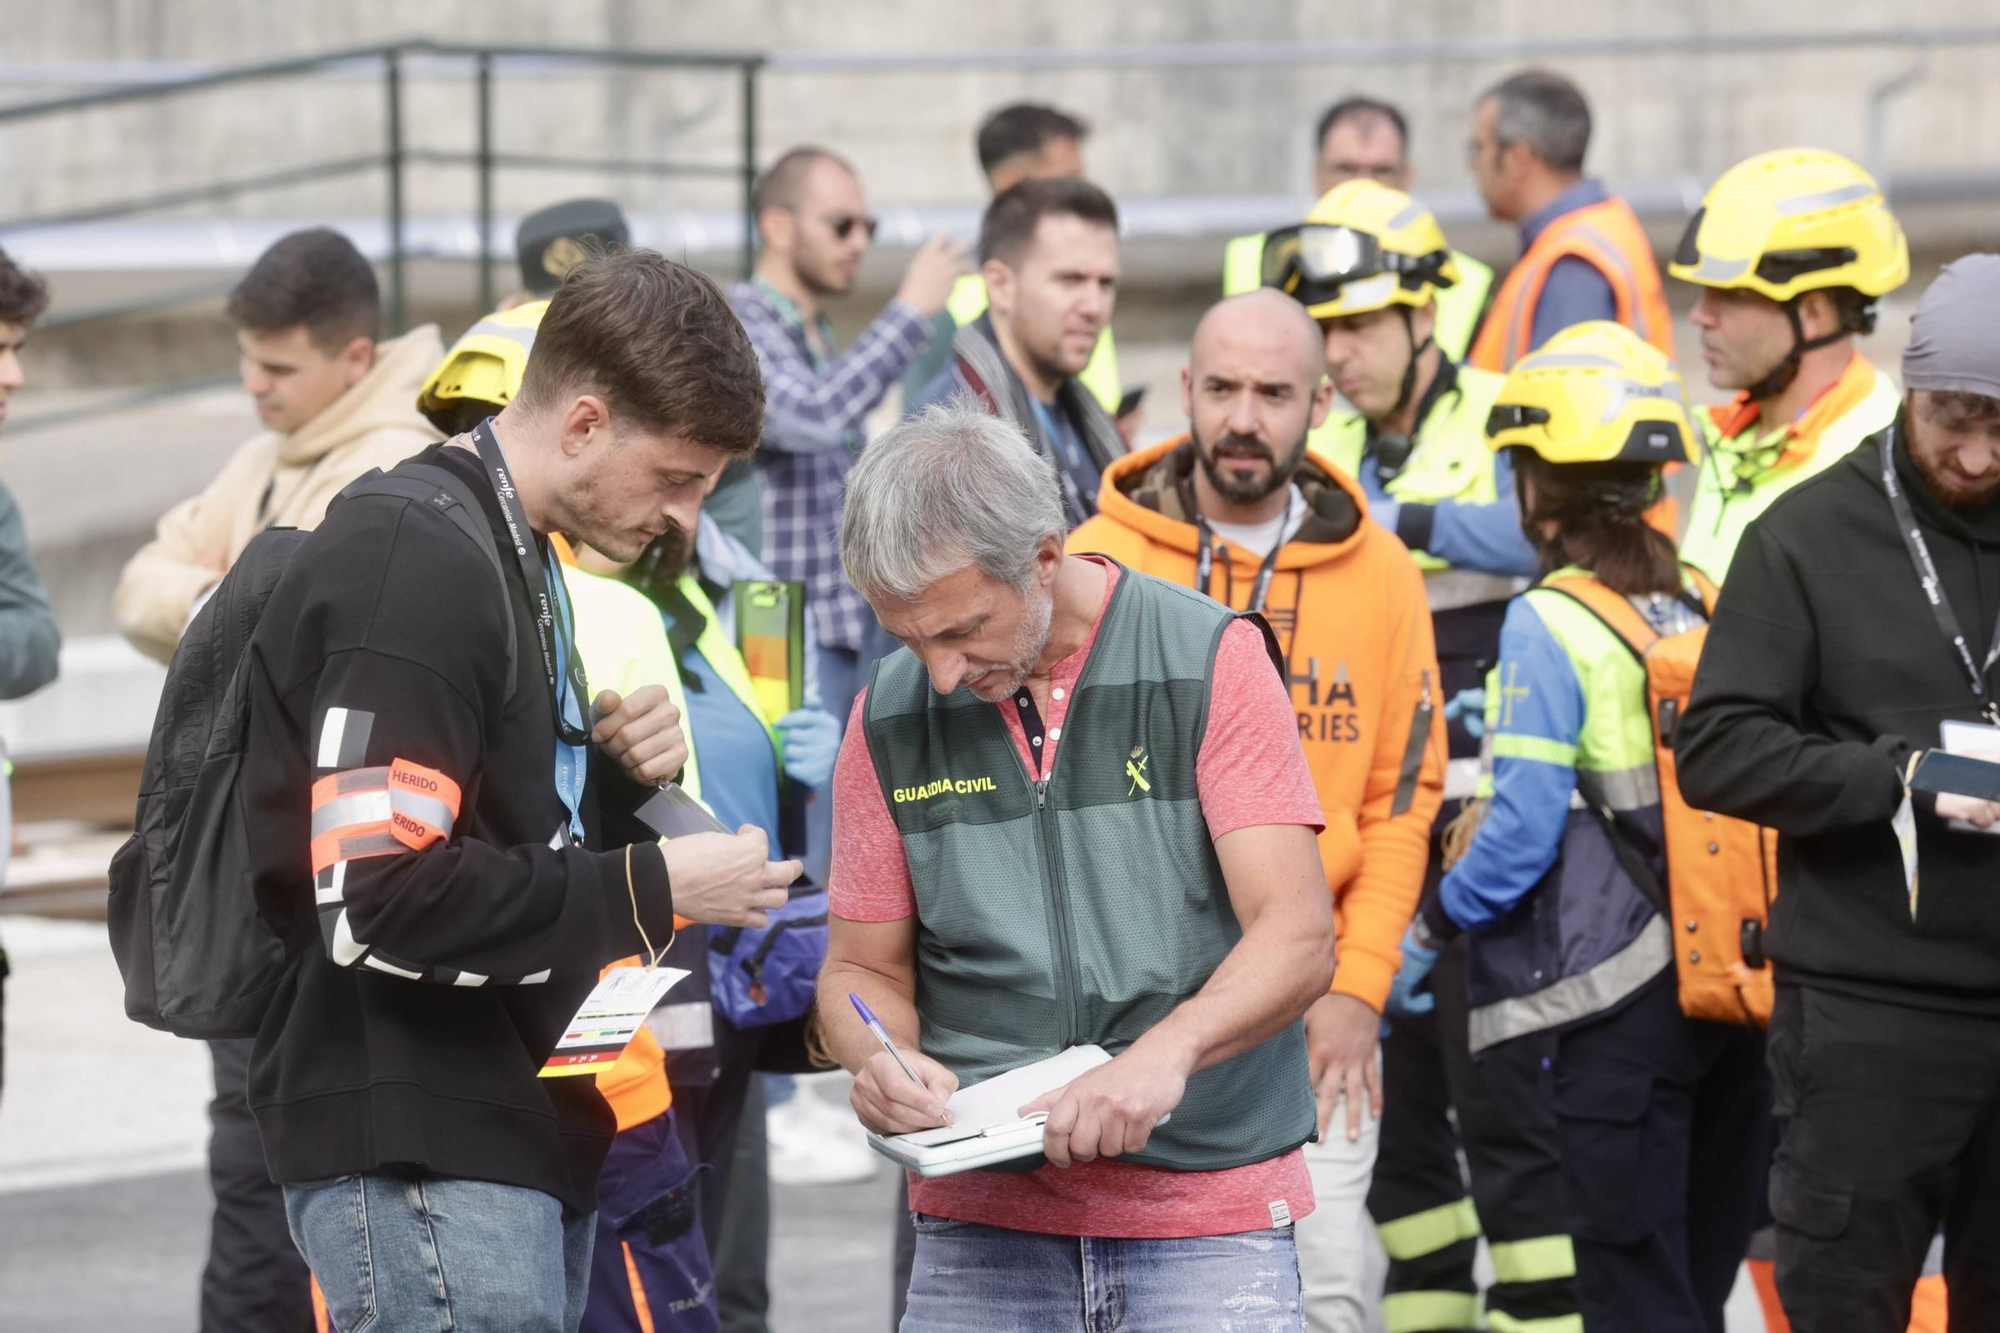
[730,278,932,650]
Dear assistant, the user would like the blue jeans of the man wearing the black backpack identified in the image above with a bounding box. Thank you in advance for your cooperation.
[284,1171,596,1333]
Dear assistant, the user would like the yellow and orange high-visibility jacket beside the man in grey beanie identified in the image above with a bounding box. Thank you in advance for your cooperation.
[1680,352,1902,584]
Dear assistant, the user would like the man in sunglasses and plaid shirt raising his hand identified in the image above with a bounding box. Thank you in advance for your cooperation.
[730,148,966,719]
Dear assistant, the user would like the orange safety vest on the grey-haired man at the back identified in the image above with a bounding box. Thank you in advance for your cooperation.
[1466,196,1674,374]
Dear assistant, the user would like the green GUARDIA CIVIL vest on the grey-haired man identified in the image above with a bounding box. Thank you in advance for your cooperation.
[864,570,1314,1171]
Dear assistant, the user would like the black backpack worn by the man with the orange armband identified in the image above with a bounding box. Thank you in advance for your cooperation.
[108,462,516,1041]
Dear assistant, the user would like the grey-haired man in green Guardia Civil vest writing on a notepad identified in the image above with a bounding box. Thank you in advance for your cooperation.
[820,404,1360,1333]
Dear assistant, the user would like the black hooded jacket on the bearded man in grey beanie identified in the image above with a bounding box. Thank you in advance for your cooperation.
[1674,422,2000,1015]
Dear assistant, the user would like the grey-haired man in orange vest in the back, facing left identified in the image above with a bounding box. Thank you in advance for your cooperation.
[1466,70,1674,372]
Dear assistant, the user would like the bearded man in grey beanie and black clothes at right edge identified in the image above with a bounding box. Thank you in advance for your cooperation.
[1674,254,2000,1333]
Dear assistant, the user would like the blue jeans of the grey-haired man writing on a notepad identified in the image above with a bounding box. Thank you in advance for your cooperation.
[902,1213,1306,1333]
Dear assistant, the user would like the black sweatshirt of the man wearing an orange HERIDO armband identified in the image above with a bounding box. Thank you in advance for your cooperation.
[244,446,672,1211]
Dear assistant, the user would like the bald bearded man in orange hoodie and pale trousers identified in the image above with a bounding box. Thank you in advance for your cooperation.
[1070,288,1444,1329]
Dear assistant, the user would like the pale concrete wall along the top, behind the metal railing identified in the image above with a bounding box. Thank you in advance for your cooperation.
[0,0,2000,218]
